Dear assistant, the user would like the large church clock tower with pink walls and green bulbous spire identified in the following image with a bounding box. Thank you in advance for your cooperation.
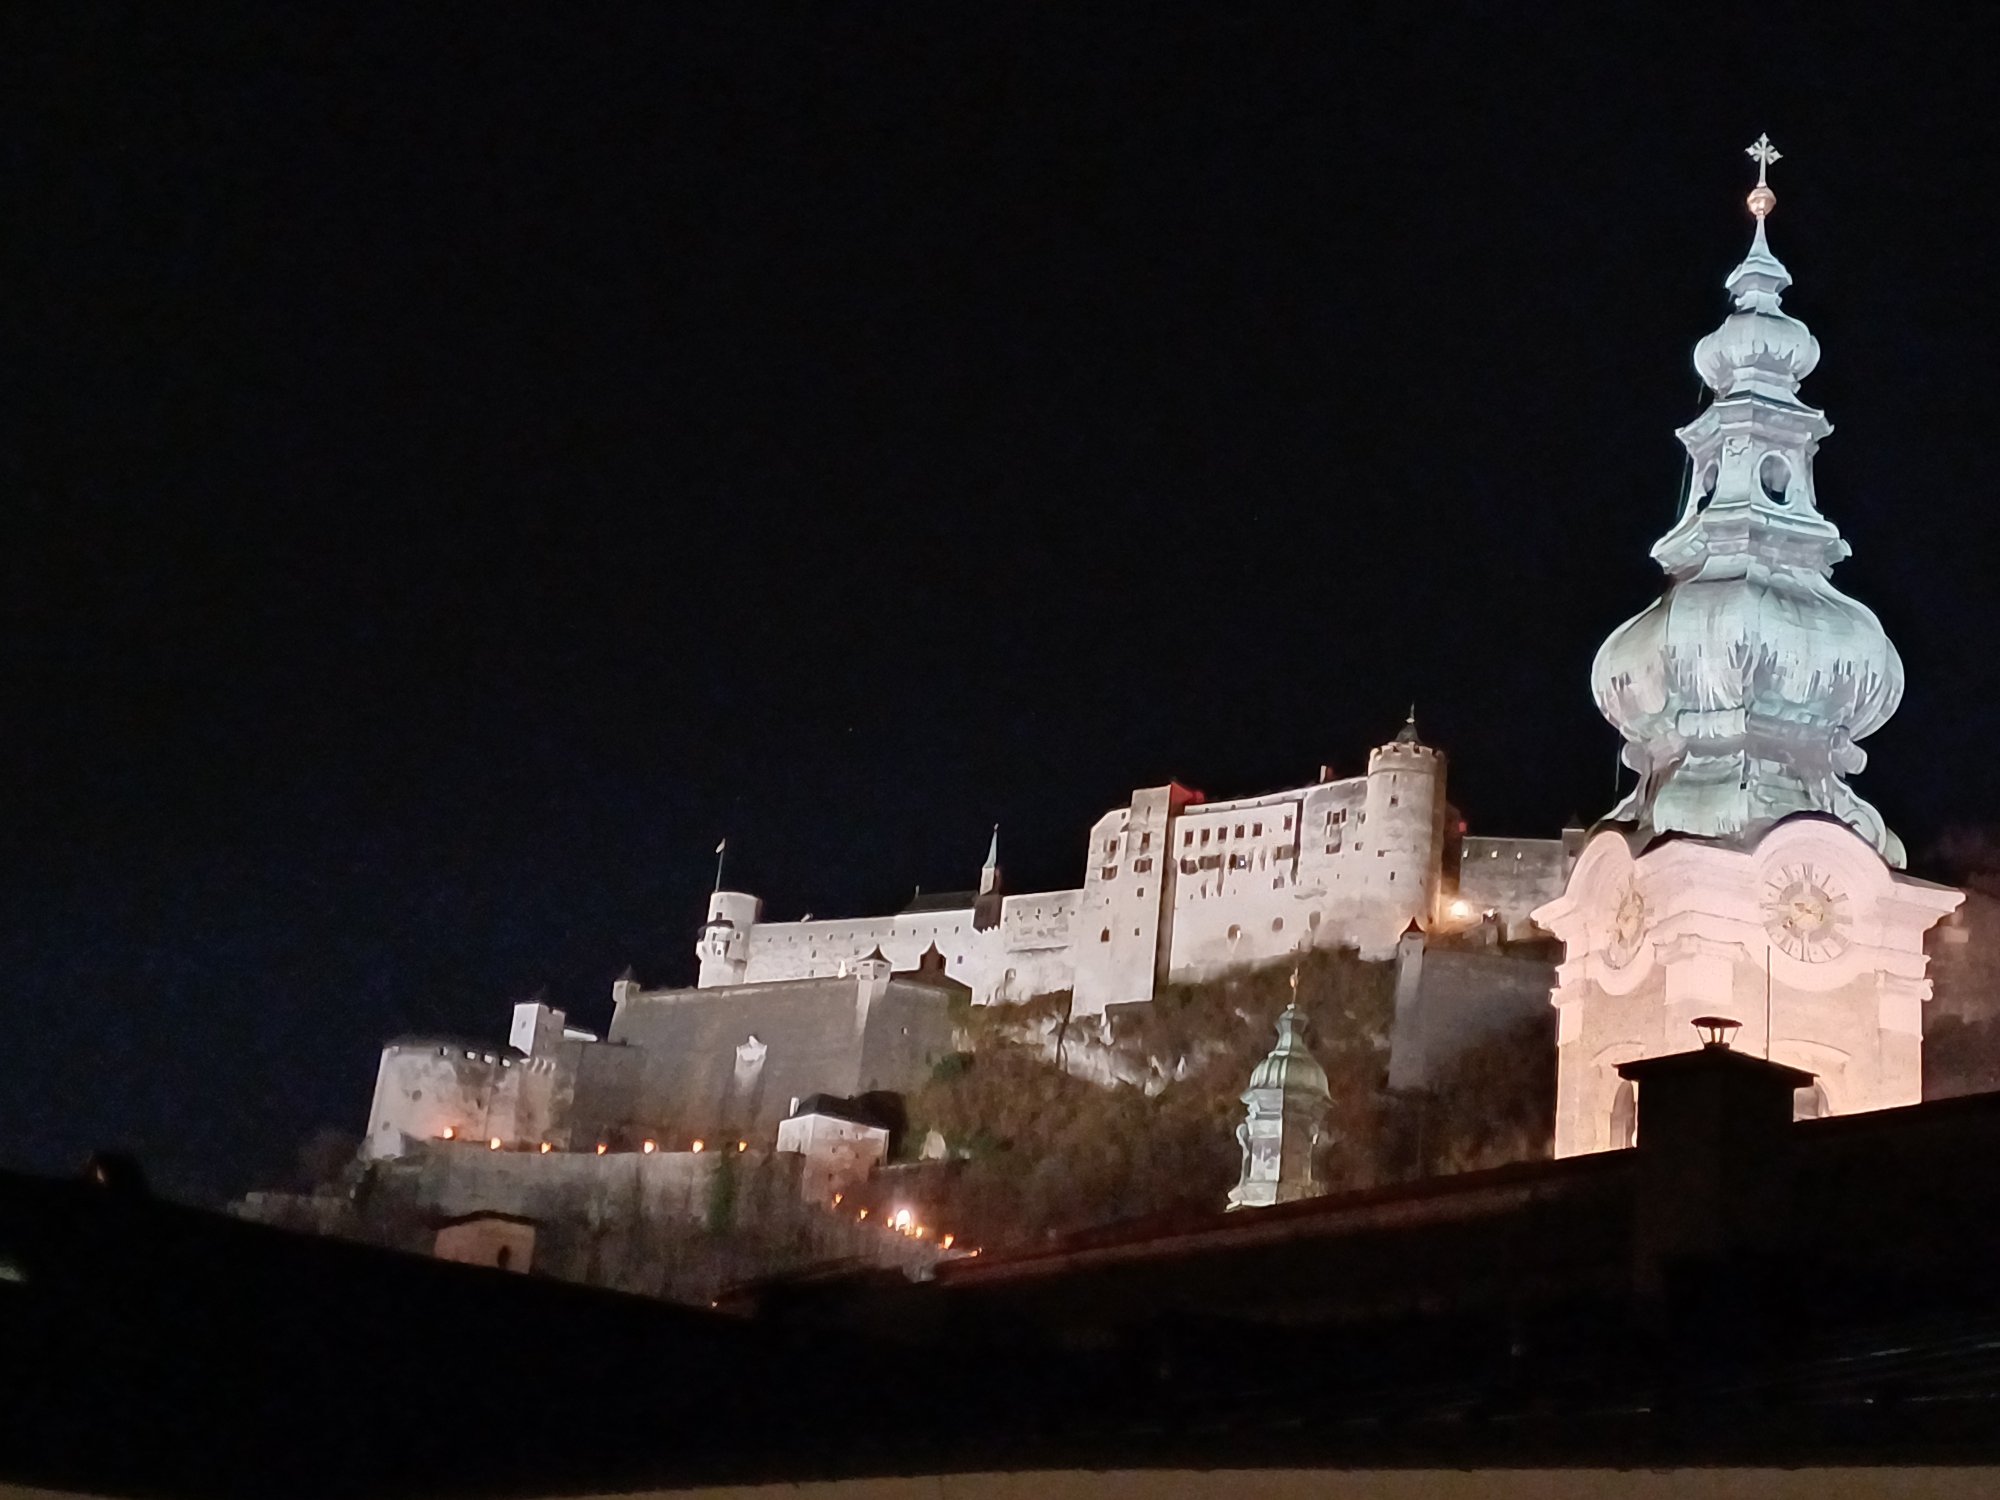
[1534,138,1962,1156]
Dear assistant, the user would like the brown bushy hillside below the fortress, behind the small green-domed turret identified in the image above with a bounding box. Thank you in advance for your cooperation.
[870,952,1554,1248]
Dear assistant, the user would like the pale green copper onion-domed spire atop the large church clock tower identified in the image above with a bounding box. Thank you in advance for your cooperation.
[1590,138,1904,866]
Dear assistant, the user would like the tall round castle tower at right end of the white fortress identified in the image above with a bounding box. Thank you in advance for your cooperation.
[1356,706,1444,958]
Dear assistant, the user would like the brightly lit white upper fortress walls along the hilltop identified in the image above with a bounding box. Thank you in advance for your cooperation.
[698,724,1574,1016]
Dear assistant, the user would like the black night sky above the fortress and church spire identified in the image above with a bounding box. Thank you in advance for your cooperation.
[11,2,2000,1194]
